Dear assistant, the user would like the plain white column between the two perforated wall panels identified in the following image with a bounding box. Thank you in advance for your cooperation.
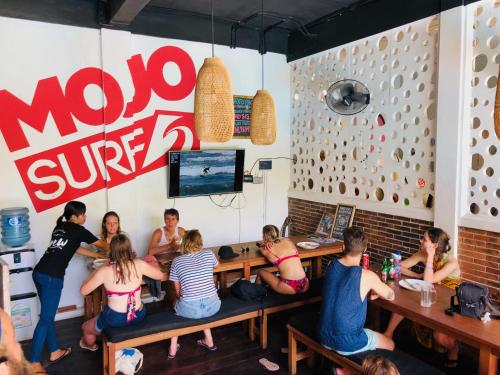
[434,6,472,251]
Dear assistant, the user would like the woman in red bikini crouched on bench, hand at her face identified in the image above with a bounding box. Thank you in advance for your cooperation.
[255,225,309,294]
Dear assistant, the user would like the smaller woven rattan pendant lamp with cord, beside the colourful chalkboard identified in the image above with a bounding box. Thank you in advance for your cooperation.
[250,0,276,146]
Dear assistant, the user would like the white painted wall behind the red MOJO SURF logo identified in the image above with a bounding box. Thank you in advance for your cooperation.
[0,18,290,317]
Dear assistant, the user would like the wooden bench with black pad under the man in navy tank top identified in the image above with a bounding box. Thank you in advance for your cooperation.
[287,312,444,375]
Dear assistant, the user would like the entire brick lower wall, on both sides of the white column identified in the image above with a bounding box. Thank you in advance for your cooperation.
[288,198,500,302]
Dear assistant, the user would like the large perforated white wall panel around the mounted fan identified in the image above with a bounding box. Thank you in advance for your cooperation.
[290,17,439,218]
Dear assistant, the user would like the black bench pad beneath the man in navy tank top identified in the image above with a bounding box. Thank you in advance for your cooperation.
[288,312,445,375]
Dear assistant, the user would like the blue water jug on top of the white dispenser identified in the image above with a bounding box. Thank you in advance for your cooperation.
[0,207,31,247]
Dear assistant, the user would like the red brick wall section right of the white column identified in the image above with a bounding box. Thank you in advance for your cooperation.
[458,227,500,301]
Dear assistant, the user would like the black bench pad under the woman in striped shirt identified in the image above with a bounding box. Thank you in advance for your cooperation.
[104,297,262,342]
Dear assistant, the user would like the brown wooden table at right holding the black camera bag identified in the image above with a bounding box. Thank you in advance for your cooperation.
[370,282,500,375]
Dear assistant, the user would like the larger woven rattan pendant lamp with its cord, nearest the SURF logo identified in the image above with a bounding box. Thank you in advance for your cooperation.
[194,0,234,142]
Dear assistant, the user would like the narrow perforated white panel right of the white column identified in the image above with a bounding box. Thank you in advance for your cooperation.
[464,0,500,220]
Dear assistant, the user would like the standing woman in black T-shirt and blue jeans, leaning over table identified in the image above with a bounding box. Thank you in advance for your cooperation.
[29,201,108,373]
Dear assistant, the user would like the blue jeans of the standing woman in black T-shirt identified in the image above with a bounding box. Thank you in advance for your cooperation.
[29,272,64,362]
